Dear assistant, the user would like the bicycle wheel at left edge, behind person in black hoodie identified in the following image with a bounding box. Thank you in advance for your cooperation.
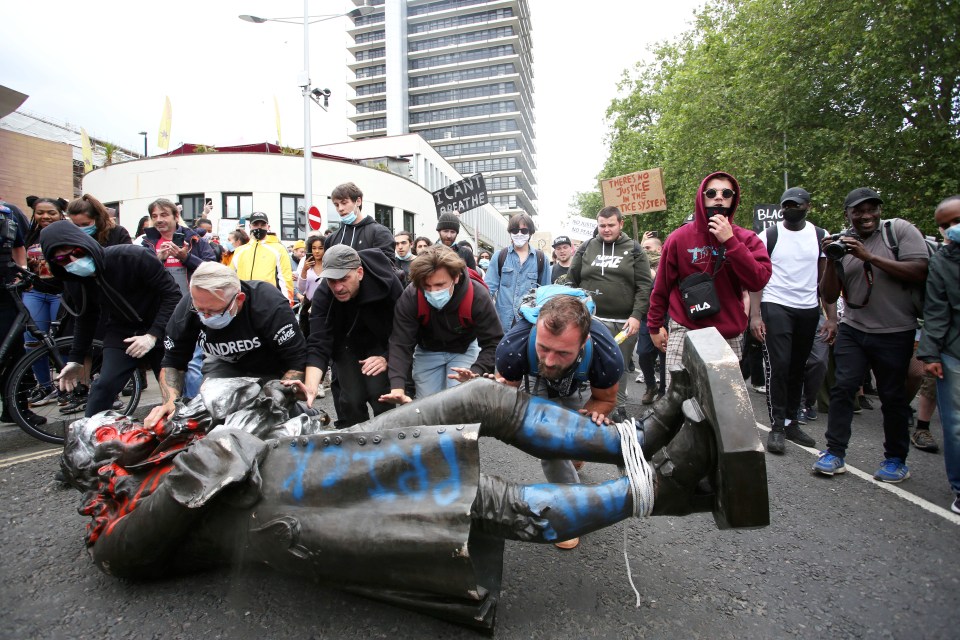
[4,336,143,444]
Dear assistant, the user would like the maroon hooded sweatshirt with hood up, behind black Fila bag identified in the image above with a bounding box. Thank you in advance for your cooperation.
[647,171,773,339]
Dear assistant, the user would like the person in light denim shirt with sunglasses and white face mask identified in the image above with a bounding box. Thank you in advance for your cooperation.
[484,213,550,333]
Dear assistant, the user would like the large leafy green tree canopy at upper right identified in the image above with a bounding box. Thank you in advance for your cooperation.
[599,0,960,234]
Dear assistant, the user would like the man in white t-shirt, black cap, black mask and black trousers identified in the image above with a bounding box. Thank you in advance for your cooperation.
[750,187,837,453]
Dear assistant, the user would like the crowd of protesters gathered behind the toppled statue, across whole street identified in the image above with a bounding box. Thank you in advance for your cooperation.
[0,172,960,524]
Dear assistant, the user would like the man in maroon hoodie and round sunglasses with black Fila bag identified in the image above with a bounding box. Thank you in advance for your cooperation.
[647,171,772,384]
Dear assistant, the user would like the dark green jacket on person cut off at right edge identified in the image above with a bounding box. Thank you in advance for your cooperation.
[917,242,960,362]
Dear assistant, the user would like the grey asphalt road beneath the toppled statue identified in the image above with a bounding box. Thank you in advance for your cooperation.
[0,385,960,640]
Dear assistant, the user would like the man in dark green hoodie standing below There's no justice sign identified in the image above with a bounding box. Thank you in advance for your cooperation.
[568,207,651,422]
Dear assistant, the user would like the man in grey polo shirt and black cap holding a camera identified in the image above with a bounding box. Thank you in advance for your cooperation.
[813,187,927,482]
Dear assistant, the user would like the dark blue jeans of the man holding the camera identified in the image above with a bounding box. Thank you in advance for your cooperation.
[827,323,916,461]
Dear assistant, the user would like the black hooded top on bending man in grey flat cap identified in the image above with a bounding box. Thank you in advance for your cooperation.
[307,249,403,371]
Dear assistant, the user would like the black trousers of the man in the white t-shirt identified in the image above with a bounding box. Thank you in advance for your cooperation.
[760,302,820,429]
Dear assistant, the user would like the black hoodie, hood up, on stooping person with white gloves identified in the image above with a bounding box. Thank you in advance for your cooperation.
[40,220,180,362]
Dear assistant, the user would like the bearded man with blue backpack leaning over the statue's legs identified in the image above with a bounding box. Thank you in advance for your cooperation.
[497,294,623,549]
